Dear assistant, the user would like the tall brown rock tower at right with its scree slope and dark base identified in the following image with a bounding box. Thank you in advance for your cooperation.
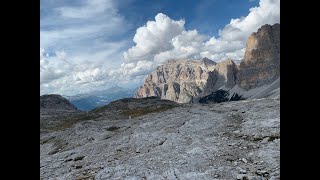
[199,24,280,103]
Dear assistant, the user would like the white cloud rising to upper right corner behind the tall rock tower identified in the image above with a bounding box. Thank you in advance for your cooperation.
[201,0,280,61]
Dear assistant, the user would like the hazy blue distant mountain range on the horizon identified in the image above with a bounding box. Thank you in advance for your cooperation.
[66,85,136,111]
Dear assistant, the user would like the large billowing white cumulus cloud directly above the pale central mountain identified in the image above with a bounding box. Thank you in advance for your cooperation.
[121,13,206,76]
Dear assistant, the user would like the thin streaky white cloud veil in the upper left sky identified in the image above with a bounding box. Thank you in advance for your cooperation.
[40,0,129,56]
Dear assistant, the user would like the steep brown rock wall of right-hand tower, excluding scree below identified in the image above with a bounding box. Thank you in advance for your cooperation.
[238,24,280,90]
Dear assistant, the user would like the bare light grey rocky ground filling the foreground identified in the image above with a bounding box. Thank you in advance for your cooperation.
[40,97,280,180]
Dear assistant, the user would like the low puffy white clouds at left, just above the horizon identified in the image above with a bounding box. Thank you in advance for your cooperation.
[40,49,112,94]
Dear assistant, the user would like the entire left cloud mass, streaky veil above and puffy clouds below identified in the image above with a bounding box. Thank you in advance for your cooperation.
[40,0,129,94]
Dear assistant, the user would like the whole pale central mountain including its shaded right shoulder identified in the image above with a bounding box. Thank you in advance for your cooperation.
[134,58,237,103]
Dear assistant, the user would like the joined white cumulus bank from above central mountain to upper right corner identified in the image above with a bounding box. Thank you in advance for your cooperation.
[123,0,280,72]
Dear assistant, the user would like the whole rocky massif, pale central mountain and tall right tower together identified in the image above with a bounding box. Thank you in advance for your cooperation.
[134,24,280,103]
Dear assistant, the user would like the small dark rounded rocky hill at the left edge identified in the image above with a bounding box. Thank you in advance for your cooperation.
[40,94,77,110]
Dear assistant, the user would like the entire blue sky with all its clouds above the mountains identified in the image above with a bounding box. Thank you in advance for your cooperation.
[40,0,280,95]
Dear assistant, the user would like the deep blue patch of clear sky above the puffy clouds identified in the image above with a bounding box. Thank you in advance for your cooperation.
[119,0,259,35]
